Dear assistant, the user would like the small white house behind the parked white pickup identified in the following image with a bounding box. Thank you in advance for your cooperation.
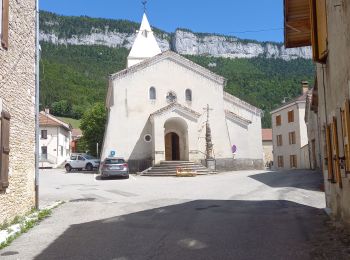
[39,110,72,168]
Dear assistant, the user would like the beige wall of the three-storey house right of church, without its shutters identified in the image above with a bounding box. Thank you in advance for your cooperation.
[271,100,308,169]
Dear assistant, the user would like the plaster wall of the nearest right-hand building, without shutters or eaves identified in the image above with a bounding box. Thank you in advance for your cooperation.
[317,0,350,225]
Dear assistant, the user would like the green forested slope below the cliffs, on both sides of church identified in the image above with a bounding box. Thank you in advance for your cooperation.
[40,43,314,127]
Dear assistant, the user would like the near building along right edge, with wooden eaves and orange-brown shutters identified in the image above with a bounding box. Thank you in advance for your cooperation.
[284,0,350,226]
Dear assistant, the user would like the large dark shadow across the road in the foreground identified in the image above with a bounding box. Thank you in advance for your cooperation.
[35,200,327,260]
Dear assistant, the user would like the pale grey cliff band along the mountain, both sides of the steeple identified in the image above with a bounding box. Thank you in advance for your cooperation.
[40,25,312,60]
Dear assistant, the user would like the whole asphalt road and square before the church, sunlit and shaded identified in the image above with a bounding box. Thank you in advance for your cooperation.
[0,170,339,260]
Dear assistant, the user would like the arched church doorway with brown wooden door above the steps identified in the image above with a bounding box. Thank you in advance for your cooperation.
[164,117,189,161]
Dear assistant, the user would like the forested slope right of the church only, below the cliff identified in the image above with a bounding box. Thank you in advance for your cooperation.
[187,56,314,128]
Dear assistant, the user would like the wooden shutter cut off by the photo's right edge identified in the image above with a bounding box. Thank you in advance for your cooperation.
[342,100,350,173]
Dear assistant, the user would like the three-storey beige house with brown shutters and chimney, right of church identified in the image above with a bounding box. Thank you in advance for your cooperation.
[271,82,309,169]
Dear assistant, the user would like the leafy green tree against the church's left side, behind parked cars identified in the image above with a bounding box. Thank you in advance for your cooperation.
[80,103,107,156]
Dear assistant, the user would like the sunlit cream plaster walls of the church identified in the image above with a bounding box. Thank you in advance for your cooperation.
[102,56,262,169]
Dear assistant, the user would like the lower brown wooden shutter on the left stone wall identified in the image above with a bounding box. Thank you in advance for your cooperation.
[0,111,11,190]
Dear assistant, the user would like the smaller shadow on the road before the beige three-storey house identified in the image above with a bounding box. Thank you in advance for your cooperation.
[249,170,323,191]
